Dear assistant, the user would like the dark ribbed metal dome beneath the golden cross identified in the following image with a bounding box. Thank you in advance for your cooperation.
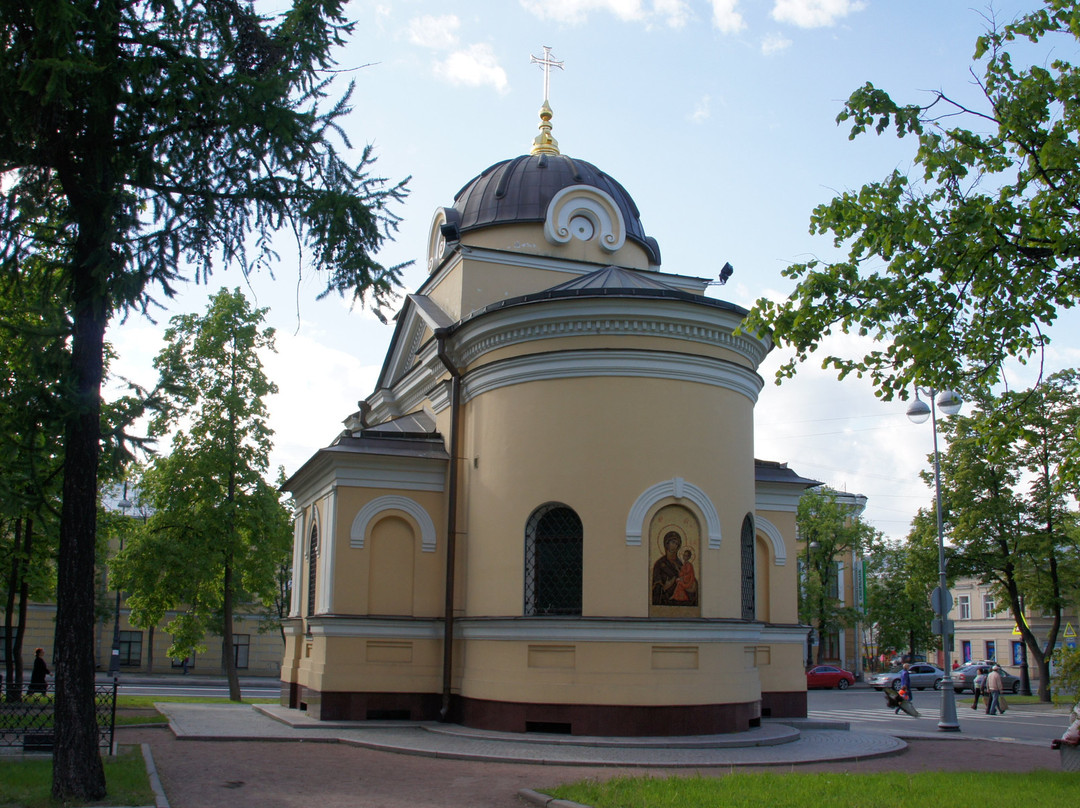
[454,154,660,265]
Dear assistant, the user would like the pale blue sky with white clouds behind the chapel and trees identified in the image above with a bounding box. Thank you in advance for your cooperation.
[110,0,1080,537]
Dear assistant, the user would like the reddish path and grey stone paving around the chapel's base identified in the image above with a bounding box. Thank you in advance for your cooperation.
[118,703,1059,808]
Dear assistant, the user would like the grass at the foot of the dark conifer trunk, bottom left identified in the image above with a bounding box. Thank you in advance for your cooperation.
[0,746,153,808]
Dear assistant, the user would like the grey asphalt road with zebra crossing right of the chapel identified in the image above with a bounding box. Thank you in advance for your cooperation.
[807,686,1069,746]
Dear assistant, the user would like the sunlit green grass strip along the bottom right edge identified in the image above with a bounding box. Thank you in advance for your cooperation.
[548,771,1080,808]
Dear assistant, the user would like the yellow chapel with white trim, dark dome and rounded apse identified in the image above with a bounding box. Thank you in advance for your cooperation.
[282,102,816,736]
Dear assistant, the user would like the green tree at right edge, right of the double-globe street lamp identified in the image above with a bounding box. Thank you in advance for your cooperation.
[924,371,1080,701]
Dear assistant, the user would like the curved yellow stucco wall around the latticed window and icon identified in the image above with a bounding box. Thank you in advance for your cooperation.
[464,377,754,617]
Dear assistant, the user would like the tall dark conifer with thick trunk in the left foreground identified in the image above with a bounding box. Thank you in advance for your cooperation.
[0,0,404,800]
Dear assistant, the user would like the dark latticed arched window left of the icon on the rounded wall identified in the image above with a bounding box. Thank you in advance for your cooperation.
[525,502,582,615]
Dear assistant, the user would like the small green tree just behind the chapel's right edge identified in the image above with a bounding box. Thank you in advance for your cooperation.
[796,488,878,663]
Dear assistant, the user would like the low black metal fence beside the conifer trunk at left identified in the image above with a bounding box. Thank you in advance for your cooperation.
[0,681,117,754]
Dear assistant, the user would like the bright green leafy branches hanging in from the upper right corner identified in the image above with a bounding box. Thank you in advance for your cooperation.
[746,0,1080,399]
